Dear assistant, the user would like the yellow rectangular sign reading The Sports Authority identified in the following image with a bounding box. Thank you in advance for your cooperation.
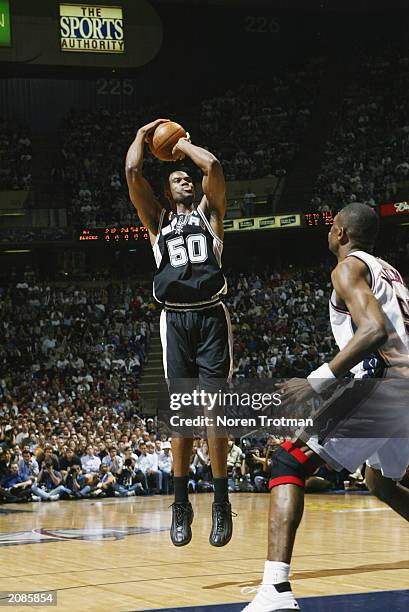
[60,4,125,53]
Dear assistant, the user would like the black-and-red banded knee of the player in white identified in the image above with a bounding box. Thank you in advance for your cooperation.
[268,442,311,489]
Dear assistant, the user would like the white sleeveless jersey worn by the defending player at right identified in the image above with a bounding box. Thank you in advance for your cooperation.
[329,251,409,378]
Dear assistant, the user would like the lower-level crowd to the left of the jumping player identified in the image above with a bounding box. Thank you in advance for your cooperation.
[0,273,162,501]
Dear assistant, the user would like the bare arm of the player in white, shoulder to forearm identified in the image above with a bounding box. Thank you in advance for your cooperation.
[328,257,388,376]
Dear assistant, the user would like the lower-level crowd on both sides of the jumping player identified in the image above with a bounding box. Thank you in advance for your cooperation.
[0,268,342,501]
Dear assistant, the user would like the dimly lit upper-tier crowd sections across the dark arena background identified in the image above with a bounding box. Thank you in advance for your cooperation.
[0,50,409,228]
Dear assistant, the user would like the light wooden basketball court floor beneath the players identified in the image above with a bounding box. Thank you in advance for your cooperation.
[0,493,409,612]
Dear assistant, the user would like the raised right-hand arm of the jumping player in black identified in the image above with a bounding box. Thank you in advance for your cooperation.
[173,138,226,238]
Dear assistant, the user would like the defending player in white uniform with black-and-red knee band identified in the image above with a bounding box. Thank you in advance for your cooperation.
[244,203,409,612]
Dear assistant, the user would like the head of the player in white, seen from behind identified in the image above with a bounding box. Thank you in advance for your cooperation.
[337,202,379,250]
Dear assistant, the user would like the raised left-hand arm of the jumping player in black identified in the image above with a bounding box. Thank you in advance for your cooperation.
[125,119,168,236]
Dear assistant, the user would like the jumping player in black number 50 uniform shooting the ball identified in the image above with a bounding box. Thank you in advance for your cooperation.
[126,119,233,546]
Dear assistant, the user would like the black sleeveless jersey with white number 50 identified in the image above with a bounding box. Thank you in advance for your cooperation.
[153,208,227,308]
